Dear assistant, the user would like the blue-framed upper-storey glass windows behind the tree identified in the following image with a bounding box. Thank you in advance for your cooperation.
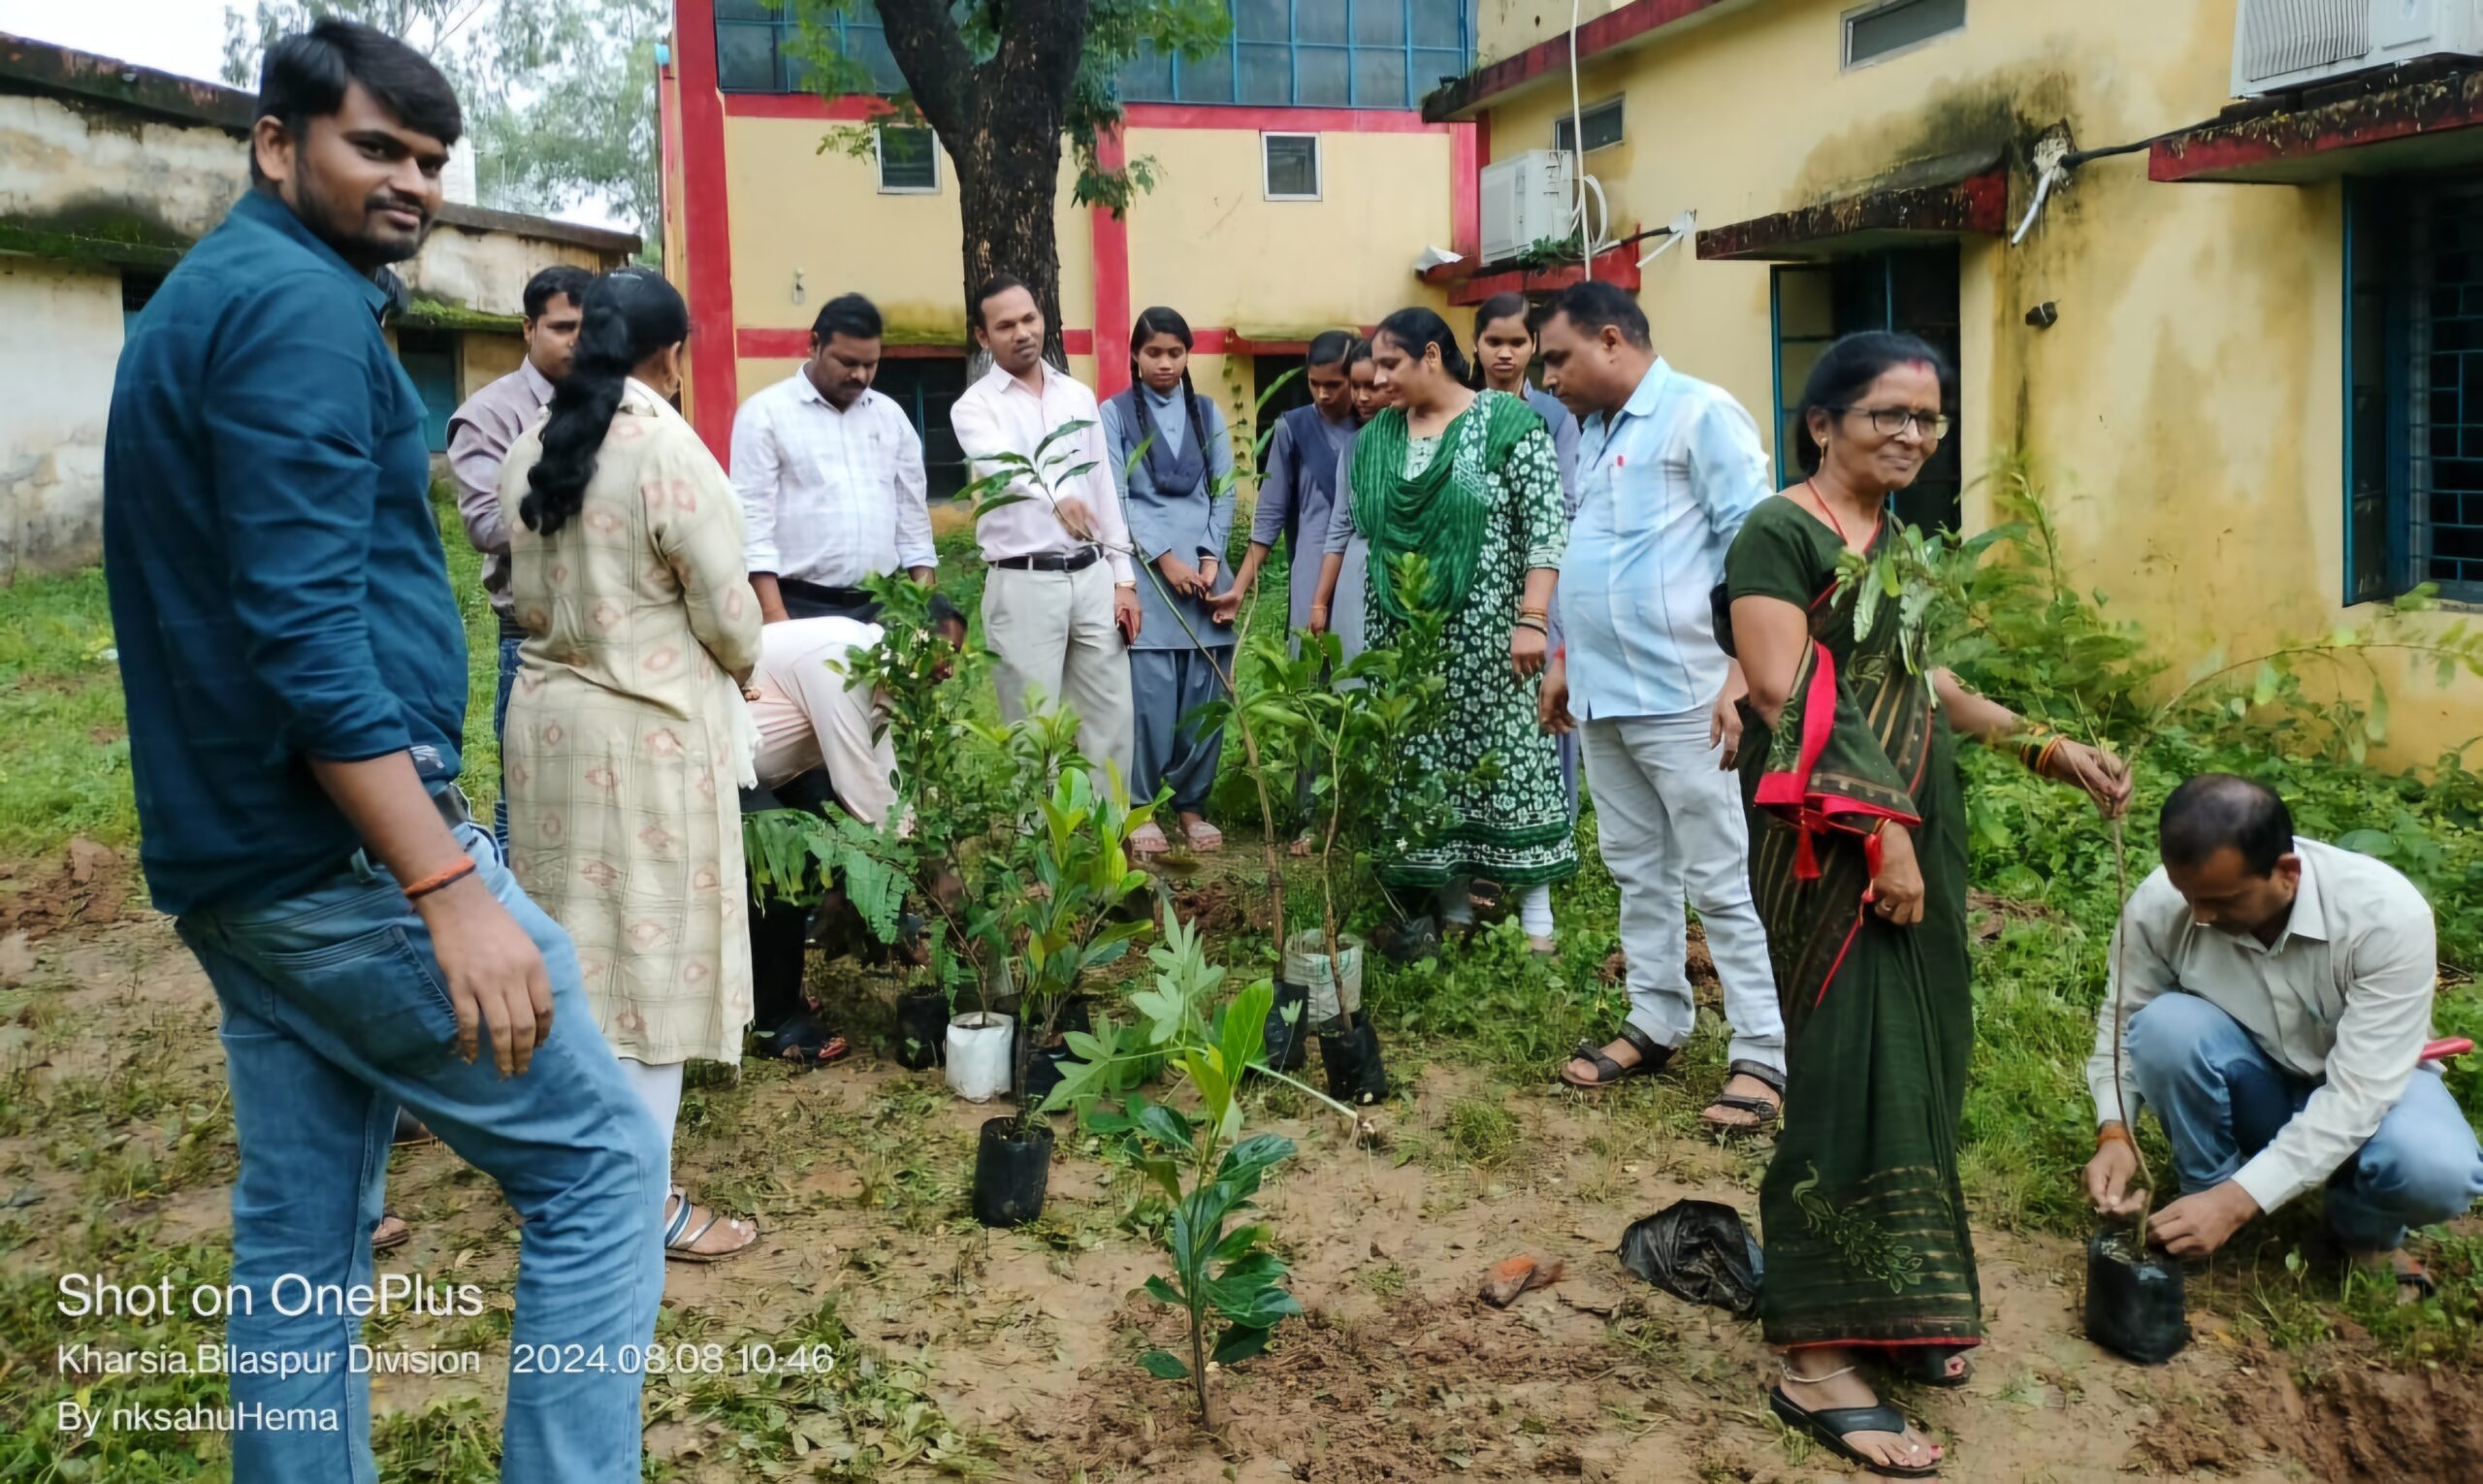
[715,0,1475,110]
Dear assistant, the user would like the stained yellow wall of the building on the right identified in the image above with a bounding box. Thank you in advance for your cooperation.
[1485,0,2483,761]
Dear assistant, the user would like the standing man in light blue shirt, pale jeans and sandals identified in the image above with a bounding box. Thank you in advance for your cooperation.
[1542,280,1786,1127]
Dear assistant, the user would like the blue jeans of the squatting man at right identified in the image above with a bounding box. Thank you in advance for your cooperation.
[2128,995,2483,1250]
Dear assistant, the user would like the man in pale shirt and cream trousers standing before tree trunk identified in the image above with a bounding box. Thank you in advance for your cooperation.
[951,275,1137,782]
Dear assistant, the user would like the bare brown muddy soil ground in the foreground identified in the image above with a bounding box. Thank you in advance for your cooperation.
[0,893,2483,1484]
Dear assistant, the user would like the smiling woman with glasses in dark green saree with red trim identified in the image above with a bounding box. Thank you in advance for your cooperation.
[1725,335,2130,1479]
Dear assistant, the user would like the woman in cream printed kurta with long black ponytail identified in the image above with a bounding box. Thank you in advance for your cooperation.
[500,271,759,1261]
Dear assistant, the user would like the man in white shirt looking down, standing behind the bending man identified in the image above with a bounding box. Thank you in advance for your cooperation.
[732,293,939,623]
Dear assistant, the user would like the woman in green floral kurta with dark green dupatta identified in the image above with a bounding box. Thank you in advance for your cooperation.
[1318,307,1577,952]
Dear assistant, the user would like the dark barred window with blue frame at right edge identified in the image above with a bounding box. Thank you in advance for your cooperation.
[2344,178,2483,603]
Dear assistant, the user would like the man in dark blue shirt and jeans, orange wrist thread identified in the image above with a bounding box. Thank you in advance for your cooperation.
[105,19,663,1484]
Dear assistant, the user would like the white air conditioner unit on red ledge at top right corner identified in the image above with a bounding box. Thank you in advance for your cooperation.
[2232,0,2483,97]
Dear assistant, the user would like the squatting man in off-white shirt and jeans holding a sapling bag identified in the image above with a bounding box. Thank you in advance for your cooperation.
[2085,774,2483,1290]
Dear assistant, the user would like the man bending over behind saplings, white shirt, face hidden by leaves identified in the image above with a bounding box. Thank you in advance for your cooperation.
[742,593,966,1070]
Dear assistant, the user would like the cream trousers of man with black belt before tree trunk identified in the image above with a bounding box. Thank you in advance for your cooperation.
[984,561,1132,784]
